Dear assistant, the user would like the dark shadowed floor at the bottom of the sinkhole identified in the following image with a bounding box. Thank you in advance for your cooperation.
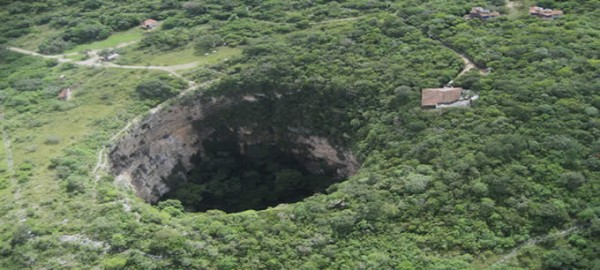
[160,126,343,212]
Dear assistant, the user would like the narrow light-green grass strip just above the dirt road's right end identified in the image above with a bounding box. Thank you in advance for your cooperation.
[117,47,242,66]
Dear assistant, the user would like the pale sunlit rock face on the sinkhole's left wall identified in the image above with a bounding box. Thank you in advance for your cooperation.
[109,99,230,202]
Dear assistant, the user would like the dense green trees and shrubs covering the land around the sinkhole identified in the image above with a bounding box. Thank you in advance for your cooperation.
[0,0,600,269]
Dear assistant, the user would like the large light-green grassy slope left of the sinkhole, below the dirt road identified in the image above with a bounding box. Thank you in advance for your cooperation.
[0,53,185,249]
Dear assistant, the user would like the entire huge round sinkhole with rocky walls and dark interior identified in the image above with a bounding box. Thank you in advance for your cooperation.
[109,94,359,213]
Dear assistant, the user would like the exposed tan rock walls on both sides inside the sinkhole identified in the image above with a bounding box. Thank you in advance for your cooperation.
[109,96,359,203]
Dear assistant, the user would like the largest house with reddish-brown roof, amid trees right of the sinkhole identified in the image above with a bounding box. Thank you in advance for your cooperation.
[421,87,479,109]
